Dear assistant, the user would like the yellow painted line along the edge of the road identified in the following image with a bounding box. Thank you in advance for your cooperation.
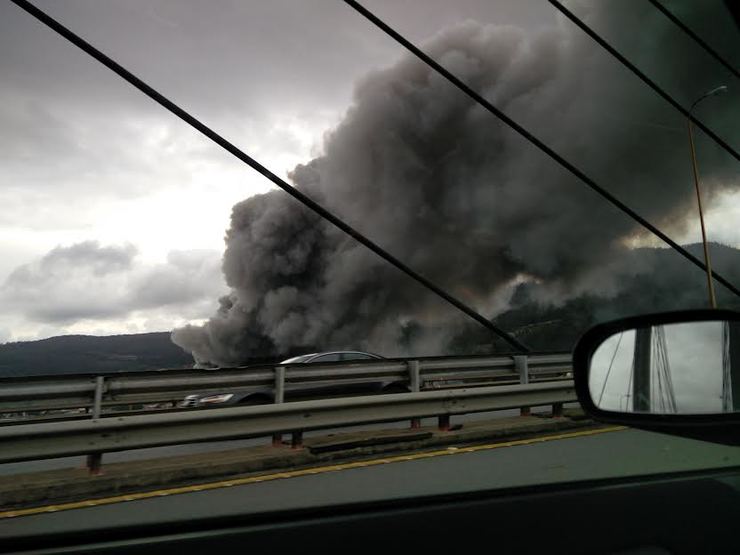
[0,426,625,519]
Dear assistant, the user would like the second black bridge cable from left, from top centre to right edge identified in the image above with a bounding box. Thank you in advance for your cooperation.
[344,0,740,297]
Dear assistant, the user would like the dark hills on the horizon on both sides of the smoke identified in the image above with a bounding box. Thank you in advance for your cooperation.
[0,244,740,377]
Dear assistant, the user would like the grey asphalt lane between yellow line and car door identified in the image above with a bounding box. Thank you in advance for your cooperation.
[0,430,740,538]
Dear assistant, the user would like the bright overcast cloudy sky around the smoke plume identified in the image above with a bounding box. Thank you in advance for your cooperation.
[0,0,740,342]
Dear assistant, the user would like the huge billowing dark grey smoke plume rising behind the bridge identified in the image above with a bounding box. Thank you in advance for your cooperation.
[173,2,737,365]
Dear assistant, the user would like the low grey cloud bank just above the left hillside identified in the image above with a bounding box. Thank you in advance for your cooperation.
[0,241,223,324]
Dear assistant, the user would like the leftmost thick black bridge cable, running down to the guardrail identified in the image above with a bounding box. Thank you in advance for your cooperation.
[10,0,529,352]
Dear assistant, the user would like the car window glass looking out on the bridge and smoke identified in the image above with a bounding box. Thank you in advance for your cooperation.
[0,0,740,538]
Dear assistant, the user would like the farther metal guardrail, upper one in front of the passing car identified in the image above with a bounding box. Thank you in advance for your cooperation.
[0,353,571,424]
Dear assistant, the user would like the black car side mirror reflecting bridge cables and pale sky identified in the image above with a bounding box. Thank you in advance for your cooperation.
[573,310,740,444]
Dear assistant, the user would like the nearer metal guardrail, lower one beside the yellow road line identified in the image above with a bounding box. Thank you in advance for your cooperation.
[0,380,576,464]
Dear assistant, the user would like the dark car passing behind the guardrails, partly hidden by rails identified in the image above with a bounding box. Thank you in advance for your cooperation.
[180,351,388,408]
